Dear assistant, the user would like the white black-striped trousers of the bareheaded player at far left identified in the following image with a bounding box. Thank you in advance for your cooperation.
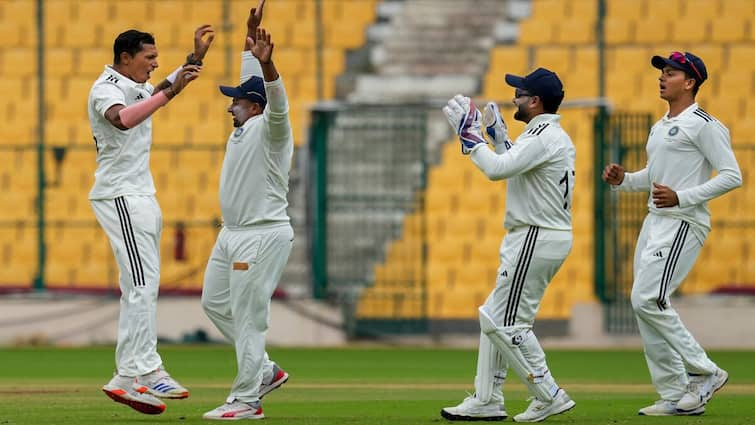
[90,195,162,376]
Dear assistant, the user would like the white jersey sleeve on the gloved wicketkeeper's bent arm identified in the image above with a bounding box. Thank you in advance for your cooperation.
[471,132,548,180]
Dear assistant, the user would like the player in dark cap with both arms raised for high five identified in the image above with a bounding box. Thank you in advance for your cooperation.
[202,1,294,420]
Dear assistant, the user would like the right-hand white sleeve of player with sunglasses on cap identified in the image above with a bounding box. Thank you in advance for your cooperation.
[676,121,742,207]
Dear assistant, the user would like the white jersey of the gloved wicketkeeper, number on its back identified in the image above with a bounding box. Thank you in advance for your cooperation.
[471,114,576,230]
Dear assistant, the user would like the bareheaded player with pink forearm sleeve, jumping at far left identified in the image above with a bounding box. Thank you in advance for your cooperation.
[88,25,214,414]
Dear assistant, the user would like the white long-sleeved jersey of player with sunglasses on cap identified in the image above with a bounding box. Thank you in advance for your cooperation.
[614,103,742,237]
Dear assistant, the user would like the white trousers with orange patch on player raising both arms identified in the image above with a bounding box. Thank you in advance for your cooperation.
[202,223,294,402]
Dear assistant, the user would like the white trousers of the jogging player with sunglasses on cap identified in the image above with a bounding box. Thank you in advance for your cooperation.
[632,214,717,401]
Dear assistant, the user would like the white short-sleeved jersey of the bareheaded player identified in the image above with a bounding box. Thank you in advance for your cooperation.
[88,65,155,199]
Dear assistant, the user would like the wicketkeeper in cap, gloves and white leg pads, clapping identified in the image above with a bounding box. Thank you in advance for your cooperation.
[441,68,576,422]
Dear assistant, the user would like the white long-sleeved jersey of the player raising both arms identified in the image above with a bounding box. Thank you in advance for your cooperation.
[220,51,294,228]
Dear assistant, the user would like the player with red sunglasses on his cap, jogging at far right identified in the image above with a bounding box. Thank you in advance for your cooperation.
[603,52,742,416]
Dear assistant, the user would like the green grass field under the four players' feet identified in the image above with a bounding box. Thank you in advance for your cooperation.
[0,346,755,425]
